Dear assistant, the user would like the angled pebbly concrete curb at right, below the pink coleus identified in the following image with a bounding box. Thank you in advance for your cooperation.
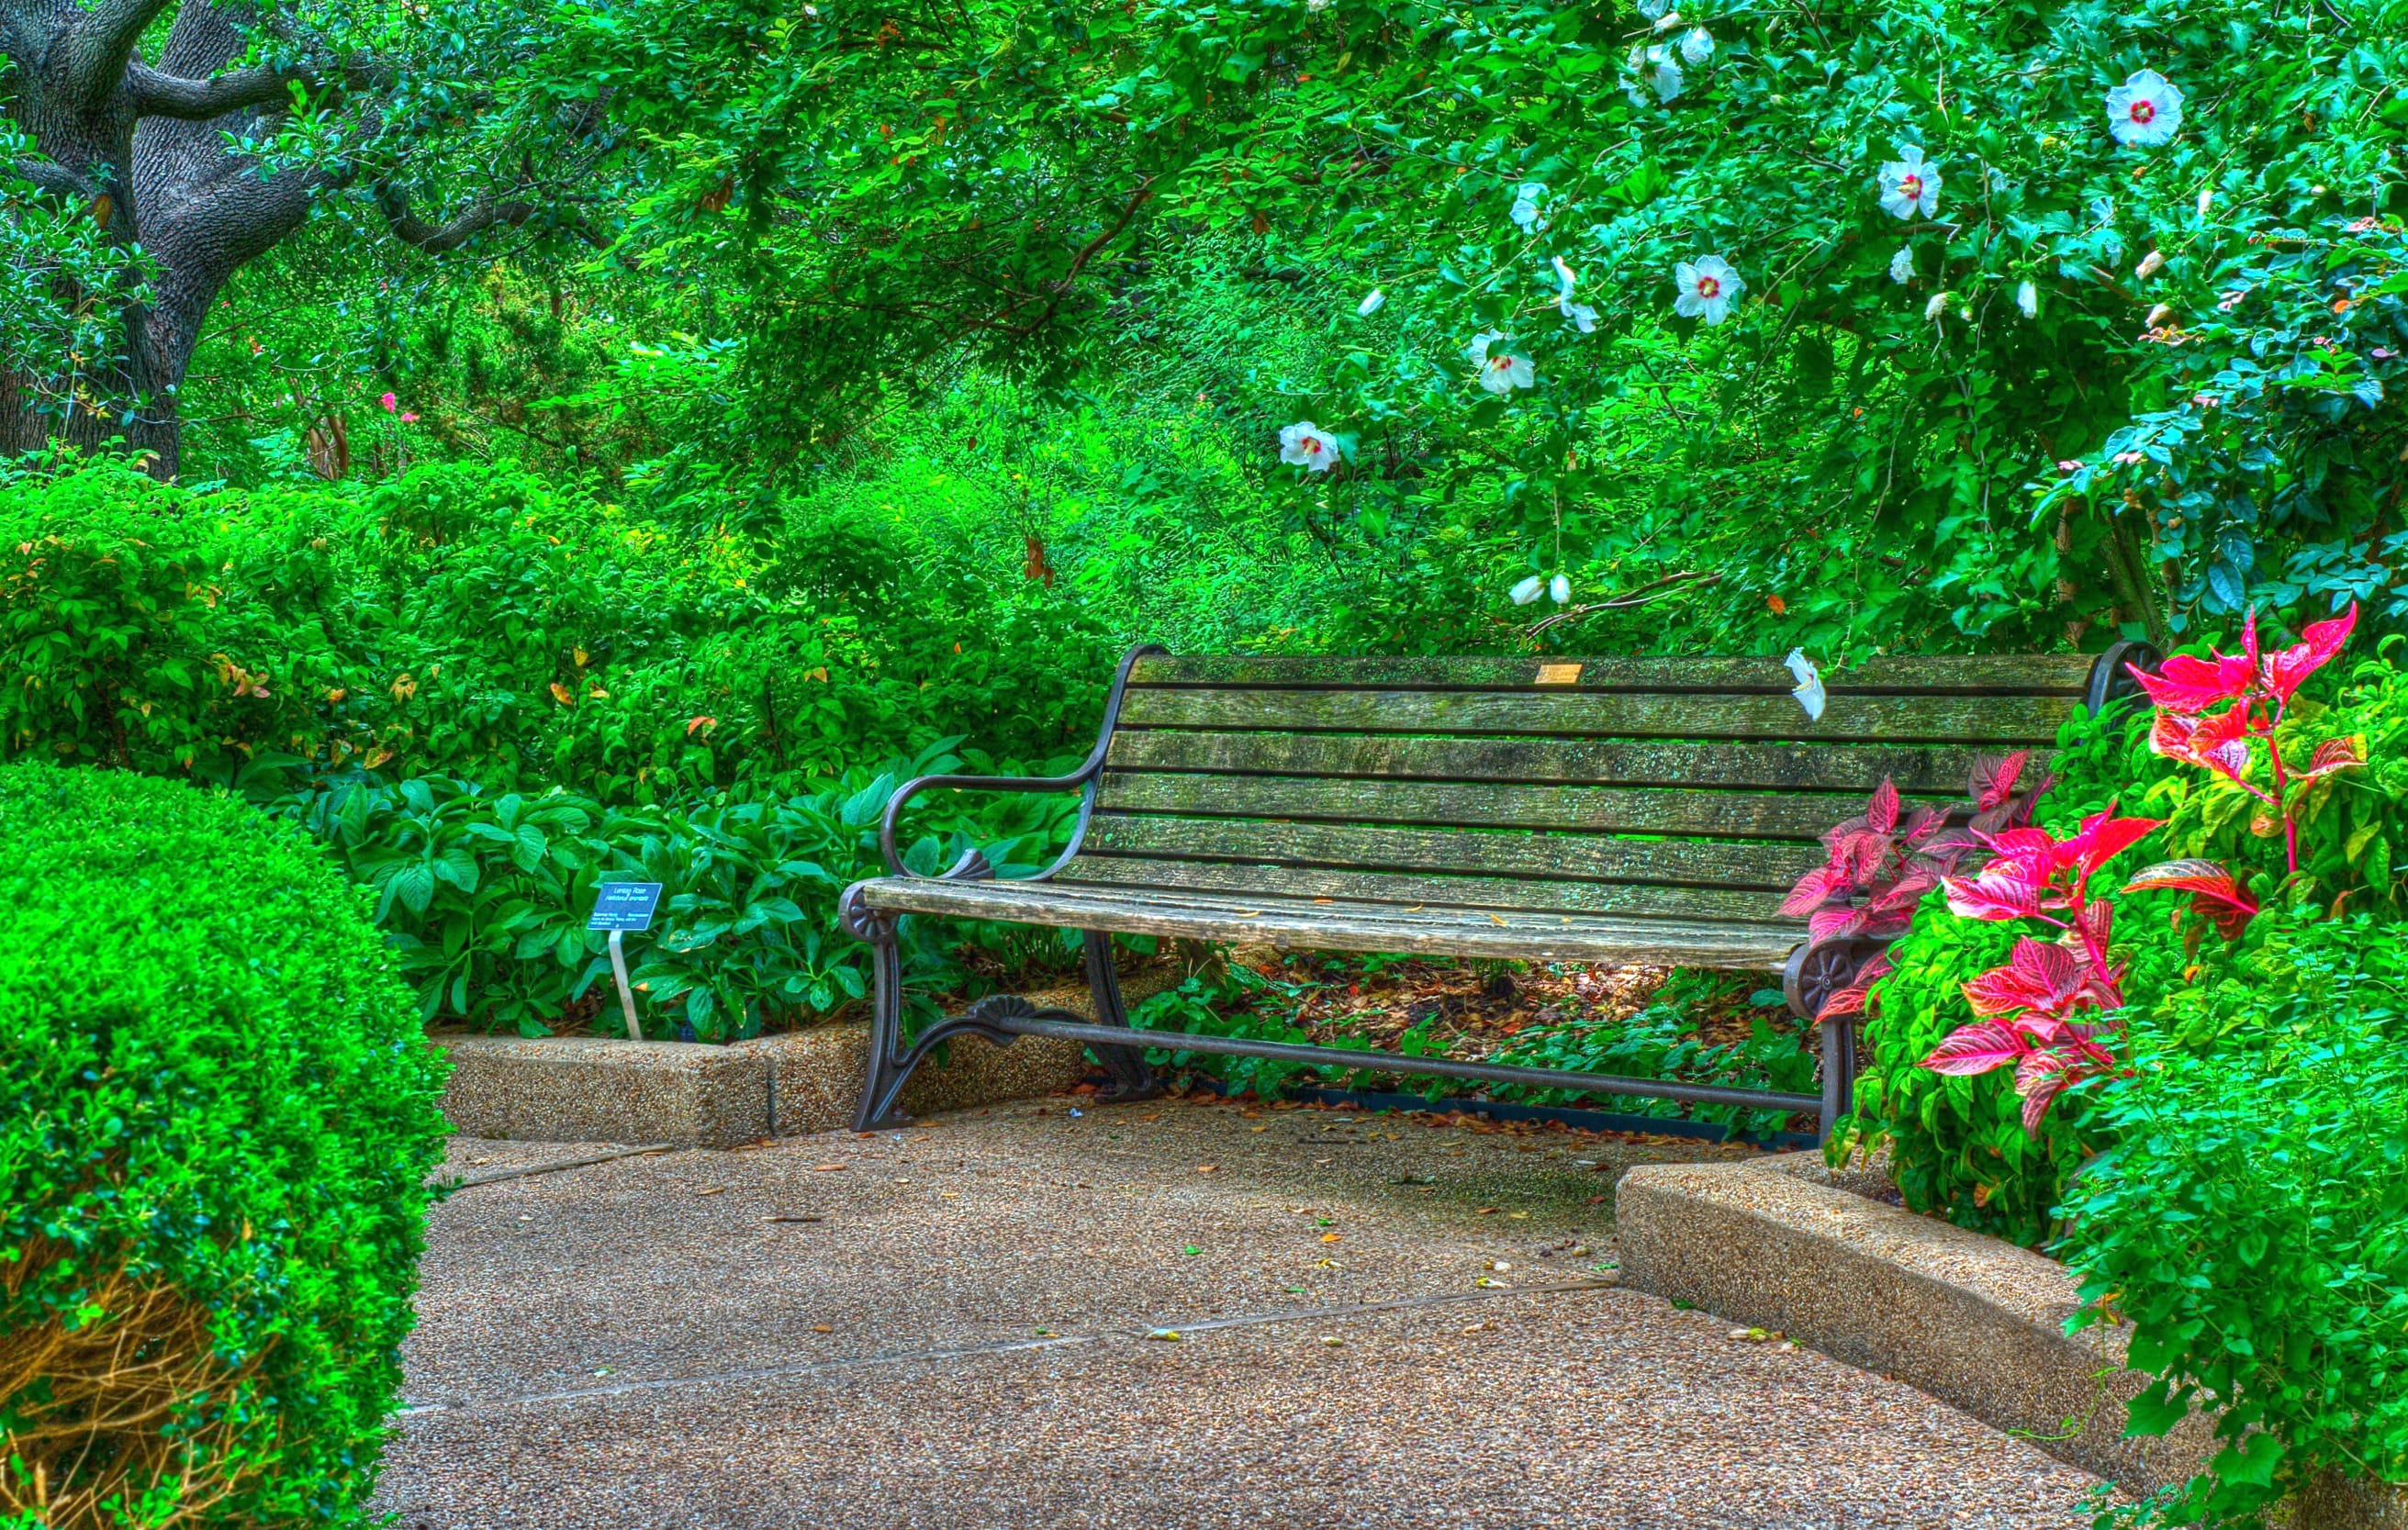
[1616,1152,2408,1530]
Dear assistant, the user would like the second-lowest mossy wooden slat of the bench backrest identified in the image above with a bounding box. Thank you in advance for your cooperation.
[1086,813,1823,892]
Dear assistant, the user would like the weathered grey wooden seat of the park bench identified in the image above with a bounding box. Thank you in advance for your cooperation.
[865,878,1801,972]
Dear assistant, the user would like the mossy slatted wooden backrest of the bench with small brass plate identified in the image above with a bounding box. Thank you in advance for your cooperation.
[1057,652,2123,923]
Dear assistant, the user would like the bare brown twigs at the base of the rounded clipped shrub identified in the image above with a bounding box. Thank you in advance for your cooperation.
[0,1239,272,1530]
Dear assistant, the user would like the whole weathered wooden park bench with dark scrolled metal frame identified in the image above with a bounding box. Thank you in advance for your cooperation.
[840,644,2134,1134]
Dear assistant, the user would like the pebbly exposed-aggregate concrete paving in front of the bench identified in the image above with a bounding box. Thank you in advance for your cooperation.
[378,1100,2098,1530]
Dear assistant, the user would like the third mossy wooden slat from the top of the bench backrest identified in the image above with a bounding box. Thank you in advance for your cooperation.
[1108,729,1982,793]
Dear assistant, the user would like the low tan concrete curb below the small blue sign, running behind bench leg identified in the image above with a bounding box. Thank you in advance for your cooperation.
[436,969,1175,1147]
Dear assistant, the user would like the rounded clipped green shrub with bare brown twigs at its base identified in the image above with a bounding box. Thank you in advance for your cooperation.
[0,763,443,1527]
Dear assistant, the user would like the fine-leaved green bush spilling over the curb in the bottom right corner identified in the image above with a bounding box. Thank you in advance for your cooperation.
[2059,914,2408,1525]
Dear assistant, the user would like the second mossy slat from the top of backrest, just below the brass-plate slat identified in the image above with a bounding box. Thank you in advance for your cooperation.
[1120,690,2073,743]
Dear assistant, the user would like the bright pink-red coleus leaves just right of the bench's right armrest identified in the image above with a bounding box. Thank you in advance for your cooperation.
[1921,803,2162,1135]
